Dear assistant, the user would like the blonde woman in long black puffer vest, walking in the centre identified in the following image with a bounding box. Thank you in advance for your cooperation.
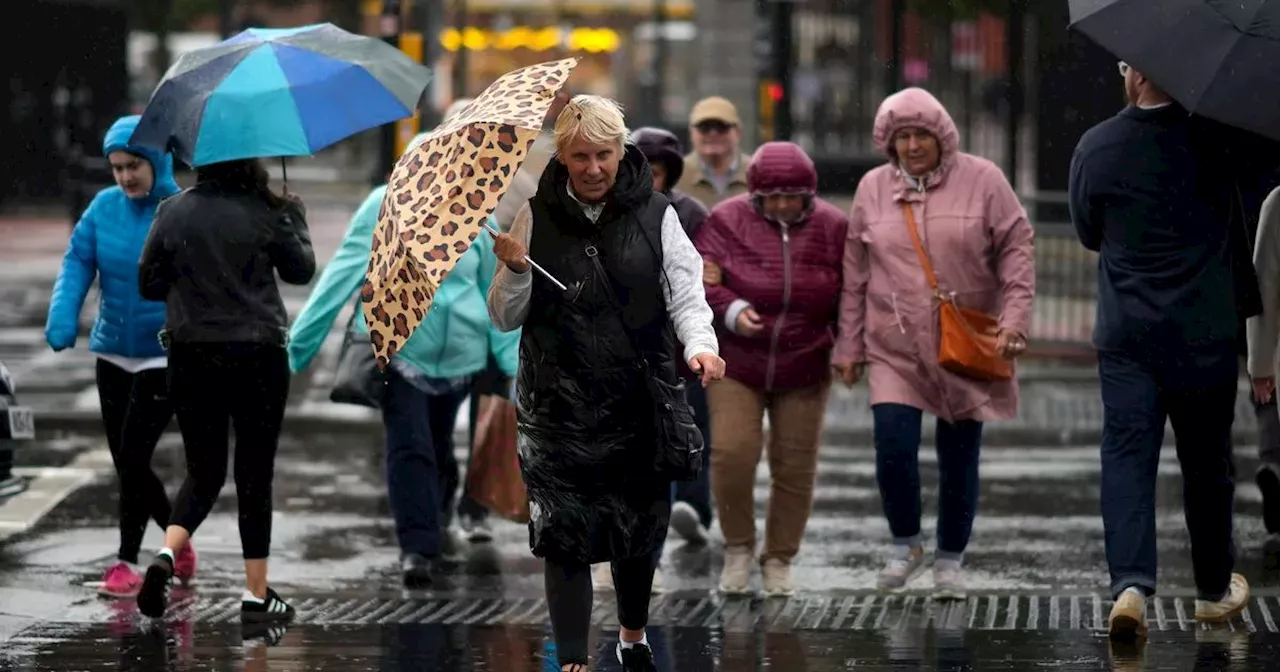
[489,95,724,672]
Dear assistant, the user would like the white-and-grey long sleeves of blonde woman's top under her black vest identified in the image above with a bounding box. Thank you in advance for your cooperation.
[488,204,719,361]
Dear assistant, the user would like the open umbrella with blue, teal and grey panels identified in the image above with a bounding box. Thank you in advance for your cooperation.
[131,23,431,166]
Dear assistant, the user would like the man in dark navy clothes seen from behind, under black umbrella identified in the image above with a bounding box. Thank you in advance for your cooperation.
[1069,63,1260,639]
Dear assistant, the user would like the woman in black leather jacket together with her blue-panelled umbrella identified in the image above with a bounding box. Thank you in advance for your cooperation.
[132,23,430,622]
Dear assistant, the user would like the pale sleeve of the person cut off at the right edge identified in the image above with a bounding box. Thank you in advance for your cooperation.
[1247,188,1280,378]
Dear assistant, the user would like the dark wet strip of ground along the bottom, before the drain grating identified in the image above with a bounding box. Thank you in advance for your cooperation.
[0,616,1280,672]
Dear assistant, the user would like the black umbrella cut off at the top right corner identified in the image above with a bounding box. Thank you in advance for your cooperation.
[1070,0,1280,140]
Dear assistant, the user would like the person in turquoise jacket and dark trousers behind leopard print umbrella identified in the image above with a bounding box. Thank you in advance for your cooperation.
[288,116,520,588]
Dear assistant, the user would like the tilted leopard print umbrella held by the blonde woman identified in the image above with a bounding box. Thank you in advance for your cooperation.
[360,59,577,370]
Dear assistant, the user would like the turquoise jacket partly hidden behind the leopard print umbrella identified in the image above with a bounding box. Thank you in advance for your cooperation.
[289,186,520,378]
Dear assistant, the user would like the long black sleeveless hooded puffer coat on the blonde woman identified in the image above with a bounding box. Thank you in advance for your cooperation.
[517,148,676,563]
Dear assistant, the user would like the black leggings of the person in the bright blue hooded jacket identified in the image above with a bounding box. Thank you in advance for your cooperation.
[96,360,173,563]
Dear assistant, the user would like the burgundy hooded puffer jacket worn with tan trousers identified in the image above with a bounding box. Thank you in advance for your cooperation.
[694,142,849,390]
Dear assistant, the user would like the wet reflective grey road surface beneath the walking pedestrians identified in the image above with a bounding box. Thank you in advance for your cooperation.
[0,424,1280,671]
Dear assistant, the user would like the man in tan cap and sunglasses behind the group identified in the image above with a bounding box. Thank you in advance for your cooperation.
[676,96,751,209]
